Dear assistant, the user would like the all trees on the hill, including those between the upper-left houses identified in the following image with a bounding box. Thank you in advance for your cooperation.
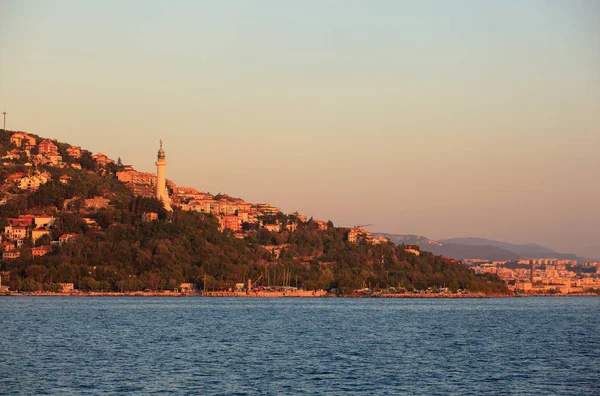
[0,131,506,293]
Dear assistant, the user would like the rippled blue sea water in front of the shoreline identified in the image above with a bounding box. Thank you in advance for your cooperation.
[0,297,600,395]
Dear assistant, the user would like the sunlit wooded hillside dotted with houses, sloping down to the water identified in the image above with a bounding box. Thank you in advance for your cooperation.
[0,131,506,293]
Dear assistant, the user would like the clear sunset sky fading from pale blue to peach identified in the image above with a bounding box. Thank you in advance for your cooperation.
[0,0,600,258]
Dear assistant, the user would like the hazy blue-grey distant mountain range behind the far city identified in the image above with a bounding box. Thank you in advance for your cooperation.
[373,233,583,261]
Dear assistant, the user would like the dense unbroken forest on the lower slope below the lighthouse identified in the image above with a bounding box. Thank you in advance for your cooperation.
[2,204,505,293]
